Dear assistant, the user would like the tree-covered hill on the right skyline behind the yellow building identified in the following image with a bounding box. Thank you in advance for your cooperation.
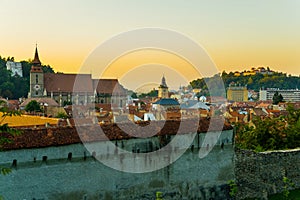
[190,71,300,95]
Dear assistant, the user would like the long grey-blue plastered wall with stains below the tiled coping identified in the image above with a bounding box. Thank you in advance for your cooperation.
[0,130,233,200]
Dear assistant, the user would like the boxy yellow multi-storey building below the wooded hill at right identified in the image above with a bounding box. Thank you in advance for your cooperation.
[227,85,248,102]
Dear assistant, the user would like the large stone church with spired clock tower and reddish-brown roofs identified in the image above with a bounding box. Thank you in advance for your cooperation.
[28,47,127,108]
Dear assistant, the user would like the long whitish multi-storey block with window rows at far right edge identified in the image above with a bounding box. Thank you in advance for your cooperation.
[259,88,300,102]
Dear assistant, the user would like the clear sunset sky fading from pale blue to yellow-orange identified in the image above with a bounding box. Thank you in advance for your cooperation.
[0,0,300,87]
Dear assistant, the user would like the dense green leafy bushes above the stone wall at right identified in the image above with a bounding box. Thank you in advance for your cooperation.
[236,106,300,152]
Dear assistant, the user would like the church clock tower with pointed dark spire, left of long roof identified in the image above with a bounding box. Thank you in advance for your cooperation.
[28,46,44,98]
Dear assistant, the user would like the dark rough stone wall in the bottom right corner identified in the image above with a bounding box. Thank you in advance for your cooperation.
[234,149,300,199]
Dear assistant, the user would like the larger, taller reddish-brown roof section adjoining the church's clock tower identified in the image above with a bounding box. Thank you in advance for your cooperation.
[44,73,93,93]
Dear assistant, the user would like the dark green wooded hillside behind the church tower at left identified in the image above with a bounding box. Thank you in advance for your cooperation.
[0,56,54,99]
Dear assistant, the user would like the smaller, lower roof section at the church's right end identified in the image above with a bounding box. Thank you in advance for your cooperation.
[92,79,126,95]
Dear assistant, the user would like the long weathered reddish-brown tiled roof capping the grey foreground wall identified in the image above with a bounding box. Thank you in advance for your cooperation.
[0,118,232,150]
